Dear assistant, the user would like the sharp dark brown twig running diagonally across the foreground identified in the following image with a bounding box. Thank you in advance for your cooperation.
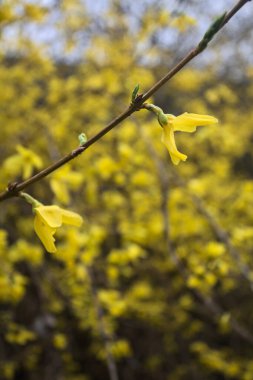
[0,0,251,201]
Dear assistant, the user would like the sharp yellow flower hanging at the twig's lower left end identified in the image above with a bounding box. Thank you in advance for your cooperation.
[34,204,83,253]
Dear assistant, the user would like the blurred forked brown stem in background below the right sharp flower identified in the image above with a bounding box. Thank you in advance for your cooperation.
[138,126,253,345]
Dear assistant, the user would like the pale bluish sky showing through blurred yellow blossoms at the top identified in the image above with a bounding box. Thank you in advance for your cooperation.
[1,0,249,67]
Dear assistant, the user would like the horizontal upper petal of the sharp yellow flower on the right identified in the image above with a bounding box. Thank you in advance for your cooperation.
[170,112,218,132]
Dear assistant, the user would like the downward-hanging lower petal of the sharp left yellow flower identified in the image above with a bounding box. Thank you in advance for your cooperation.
[34,215,56,253]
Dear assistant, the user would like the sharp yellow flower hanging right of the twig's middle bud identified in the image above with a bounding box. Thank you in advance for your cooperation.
[161,112,218,165]
